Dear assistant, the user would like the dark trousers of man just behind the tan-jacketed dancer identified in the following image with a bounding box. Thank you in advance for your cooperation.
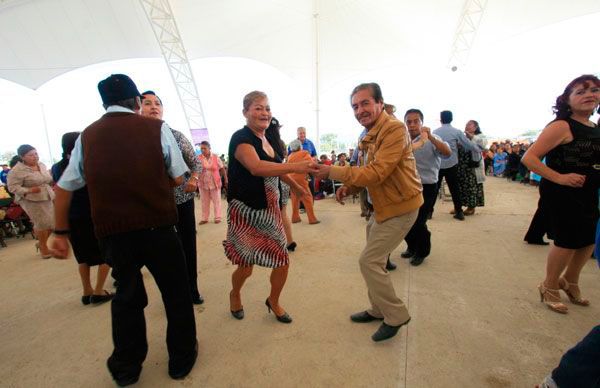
[404,183,438,257]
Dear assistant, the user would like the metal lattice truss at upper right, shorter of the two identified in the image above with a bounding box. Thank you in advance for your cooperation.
[448,0,487,71]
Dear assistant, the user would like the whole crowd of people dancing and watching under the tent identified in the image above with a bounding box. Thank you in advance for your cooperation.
[6,74,600,386]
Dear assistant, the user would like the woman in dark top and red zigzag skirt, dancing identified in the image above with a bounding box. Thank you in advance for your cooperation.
[223,91,317,323]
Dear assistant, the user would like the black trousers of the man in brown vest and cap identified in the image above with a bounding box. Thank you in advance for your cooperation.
[101,226,196,378]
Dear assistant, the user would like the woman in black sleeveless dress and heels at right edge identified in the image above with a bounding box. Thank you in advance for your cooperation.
[522,75,600,314]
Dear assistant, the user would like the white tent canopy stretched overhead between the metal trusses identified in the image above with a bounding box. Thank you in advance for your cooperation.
[0,0,600,90]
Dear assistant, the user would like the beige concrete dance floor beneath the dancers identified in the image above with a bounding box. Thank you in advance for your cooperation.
[0,178,600,388]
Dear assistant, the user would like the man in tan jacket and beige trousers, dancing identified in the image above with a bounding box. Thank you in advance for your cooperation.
[318,83,423,341]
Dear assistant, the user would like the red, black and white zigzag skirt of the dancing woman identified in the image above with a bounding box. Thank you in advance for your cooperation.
[223,177,289,268]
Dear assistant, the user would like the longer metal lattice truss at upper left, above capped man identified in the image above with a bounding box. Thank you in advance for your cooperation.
[140,0,206,137]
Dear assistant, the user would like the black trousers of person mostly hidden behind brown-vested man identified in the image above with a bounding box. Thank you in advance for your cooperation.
[177,198,200,299]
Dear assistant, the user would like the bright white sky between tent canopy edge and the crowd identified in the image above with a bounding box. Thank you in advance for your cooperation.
[0,11,600,163]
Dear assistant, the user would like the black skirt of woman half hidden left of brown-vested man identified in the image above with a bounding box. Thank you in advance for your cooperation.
[69,218,105,267]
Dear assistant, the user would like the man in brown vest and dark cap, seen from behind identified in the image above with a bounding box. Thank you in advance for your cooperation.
[52,74,198,386]
